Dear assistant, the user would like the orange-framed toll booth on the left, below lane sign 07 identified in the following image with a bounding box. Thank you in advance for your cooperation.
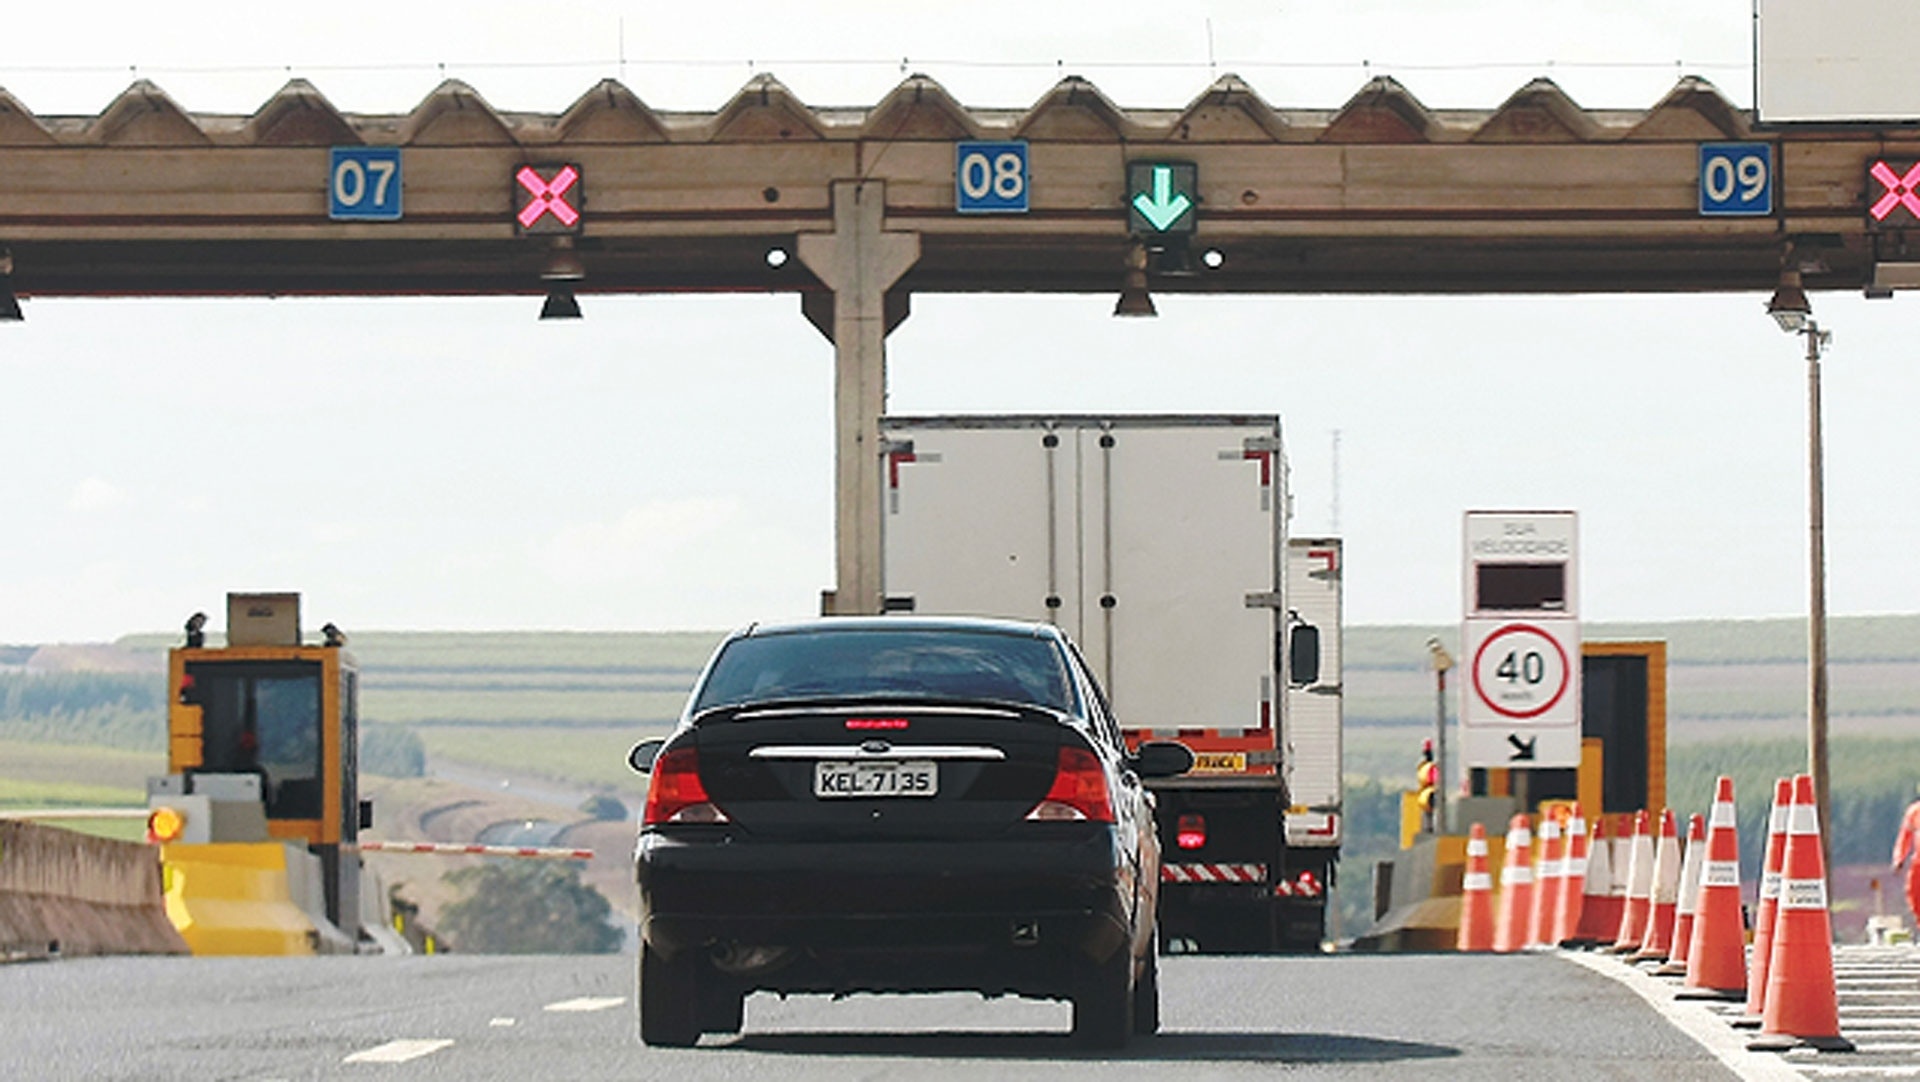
[167,593,369,936]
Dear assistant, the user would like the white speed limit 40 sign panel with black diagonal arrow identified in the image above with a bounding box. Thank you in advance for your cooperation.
[1461,616,1580,767]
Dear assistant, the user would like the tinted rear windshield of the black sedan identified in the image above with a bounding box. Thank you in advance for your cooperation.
[693,629,1073,714]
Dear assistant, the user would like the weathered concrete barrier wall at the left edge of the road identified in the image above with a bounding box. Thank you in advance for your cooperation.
[0,819,186,961]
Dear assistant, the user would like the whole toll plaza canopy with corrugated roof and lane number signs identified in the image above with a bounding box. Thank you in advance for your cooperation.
[0,77,1920,297]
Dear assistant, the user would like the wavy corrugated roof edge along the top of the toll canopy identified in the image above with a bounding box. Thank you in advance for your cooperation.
[0,75,1751,146]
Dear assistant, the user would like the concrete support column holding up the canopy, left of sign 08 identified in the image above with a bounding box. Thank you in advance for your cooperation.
[799,180,920,614]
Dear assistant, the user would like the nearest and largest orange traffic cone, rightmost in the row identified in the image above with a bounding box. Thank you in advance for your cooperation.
[1747,773,1853,1051]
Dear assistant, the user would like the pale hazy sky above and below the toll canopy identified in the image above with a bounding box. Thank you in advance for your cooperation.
[0,0,1920,643]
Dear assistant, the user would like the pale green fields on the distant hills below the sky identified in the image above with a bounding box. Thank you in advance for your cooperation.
[0,616,1920,796]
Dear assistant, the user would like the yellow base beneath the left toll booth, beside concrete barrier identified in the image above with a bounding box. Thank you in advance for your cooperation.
[159,842,319,955]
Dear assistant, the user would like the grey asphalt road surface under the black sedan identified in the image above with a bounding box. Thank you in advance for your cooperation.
[0,955,1734,1082]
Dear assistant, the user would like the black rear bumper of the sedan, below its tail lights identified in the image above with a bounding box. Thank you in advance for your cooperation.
[636,829,1133,994]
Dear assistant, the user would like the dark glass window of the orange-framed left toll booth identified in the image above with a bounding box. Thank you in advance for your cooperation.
[188,662,323,819]
